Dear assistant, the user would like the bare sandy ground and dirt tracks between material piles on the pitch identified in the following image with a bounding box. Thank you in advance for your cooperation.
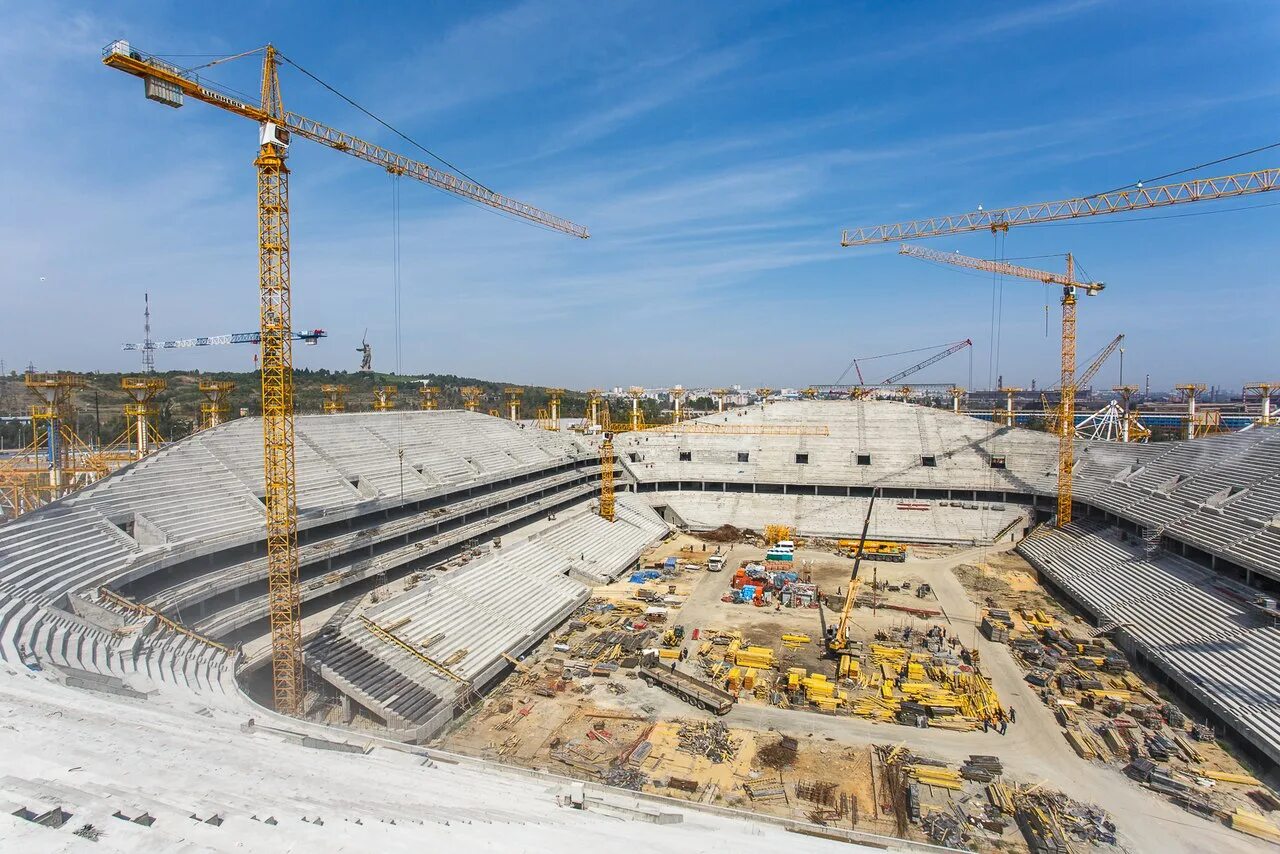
[440,535,1275,854]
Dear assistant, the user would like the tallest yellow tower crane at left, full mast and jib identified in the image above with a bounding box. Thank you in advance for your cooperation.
[102,40,589,714]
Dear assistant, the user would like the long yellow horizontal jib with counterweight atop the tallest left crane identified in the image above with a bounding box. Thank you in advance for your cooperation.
[102,41,590,238]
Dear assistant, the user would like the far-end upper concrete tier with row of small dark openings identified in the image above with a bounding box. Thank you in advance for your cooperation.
[617,401,1057,507]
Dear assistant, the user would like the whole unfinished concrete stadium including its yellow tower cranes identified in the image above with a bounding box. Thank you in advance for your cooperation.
[0,25,1280,854]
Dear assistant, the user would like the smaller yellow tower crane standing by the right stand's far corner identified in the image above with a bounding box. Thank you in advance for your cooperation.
[899,246,1106,526]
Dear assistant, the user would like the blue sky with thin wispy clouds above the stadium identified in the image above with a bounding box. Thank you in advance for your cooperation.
[0,0,1280,388]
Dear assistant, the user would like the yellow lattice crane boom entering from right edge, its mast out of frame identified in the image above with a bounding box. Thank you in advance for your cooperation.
[840,169,1280,246]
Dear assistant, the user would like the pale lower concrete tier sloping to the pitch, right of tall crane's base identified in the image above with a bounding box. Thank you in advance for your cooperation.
[307,494,669,741]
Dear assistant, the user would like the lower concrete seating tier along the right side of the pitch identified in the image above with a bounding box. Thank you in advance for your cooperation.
[1016,521,1280,768]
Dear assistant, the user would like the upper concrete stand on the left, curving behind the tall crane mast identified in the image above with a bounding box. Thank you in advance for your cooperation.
[0,411,614,703]
